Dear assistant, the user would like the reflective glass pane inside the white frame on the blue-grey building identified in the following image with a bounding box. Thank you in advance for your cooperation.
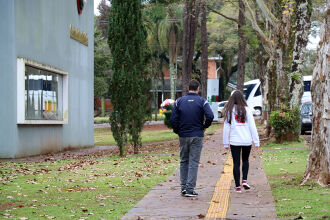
[25,65,63,120]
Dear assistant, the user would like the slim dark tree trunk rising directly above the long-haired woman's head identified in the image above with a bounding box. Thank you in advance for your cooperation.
[237,0,246,92]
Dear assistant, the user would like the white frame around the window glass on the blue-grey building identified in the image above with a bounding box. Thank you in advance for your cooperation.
[17,58,69,125]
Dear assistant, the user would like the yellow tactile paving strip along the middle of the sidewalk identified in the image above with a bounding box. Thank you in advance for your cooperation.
[205,155,233,219]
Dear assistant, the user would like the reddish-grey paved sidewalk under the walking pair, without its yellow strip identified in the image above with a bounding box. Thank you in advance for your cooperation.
[122,128,276,220]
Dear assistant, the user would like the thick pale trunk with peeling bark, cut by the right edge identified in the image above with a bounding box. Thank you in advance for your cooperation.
[303,1,330,186]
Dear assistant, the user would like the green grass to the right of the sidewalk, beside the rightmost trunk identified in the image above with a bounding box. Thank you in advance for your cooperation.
[263,142,330,219]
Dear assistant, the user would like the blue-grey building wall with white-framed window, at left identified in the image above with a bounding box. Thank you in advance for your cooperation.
[0,0,94,158]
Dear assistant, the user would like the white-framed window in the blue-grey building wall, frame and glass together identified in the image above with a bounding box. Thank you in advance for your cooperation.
[17,58,68,124]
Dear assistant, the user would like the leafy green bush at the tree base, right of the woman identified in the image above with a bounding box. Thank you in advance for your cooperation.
[270,107,300,143]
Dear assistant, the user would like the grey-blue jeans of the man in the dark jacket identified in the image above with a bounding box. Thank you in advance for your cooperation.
[179,137,203,191]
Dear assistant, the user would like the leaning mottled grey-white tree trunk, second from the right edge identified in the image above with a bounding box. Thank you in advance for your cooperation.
[289,0,312,108]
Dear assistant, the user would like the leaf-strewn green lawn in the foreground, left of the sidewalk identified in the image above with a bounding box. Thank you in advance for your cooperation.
[0,155,178,219]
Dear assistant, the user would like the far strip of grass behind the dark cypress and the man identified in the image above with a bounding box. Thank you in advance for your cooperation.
[94,124,220,146]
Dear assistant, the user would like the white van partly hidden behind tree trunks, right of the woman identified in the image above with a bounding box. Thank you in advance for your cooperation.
[243,76,312,116]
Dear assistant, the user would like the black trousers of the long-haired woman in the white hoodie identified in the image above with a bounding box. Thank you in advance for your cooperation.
[230,145,251,187]
